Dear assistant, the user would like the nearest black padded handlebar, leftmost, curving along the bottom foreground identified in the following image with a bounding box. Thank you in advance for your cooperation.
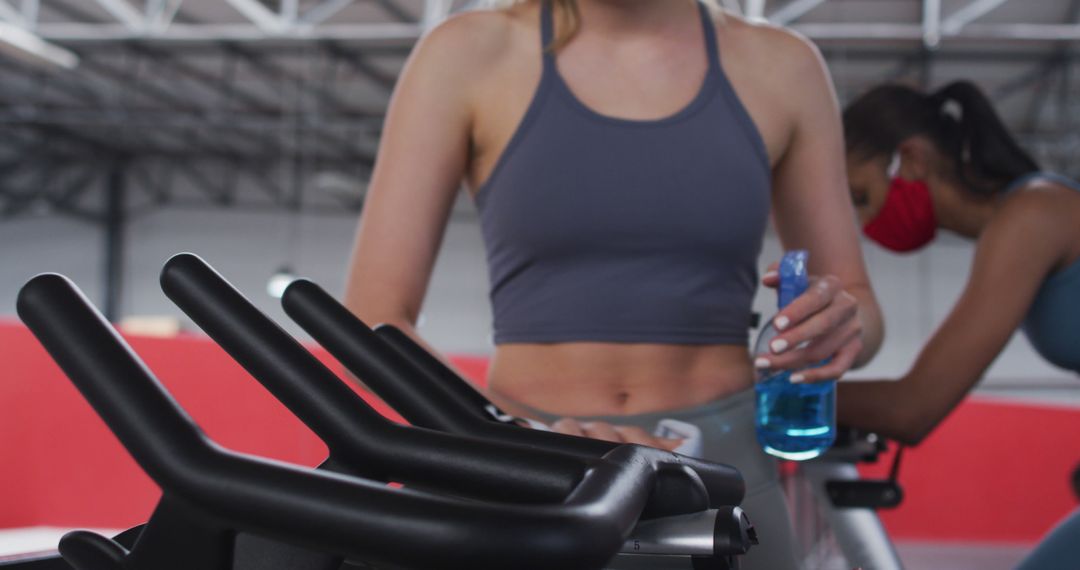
[16,274,662,570]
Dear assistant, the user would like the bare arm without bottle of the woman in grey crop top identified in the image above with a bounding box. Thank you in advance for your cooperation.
[345,15,494,364]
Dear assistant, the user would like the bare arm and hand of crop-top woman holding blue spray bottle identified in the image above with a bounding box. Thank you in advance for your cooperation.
[766,31,883,381]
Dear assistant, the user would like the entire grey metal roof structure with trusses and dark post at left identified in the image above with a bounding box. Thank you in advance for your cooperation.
[0,0,1080,323]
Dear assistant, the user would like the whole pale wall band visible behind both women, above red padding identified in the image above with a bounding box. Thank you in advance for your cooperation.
[0,191,1076,385]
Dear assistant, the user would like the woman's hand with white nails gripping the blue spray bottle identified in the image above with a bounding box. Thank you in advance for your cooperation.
[754,264,863,383]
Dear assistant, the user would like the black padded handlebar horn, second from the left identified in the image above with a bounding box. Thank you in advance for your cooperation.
[161,254,588,503]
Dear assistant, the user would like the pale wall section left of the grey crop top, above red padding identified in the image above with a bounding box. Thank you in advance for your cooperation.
[0,193,490,353]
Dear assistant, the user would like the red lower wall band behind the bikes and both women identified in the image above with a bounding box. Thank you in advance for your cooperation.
[0,323,1080,542]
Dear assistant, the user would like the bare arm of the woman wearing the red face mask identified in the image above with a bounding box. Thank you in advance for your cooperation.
[838,191,1072,445]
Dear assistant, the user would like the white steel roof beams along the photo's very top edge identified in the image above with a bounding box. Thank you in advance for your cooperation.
[0,0,1080,48]
